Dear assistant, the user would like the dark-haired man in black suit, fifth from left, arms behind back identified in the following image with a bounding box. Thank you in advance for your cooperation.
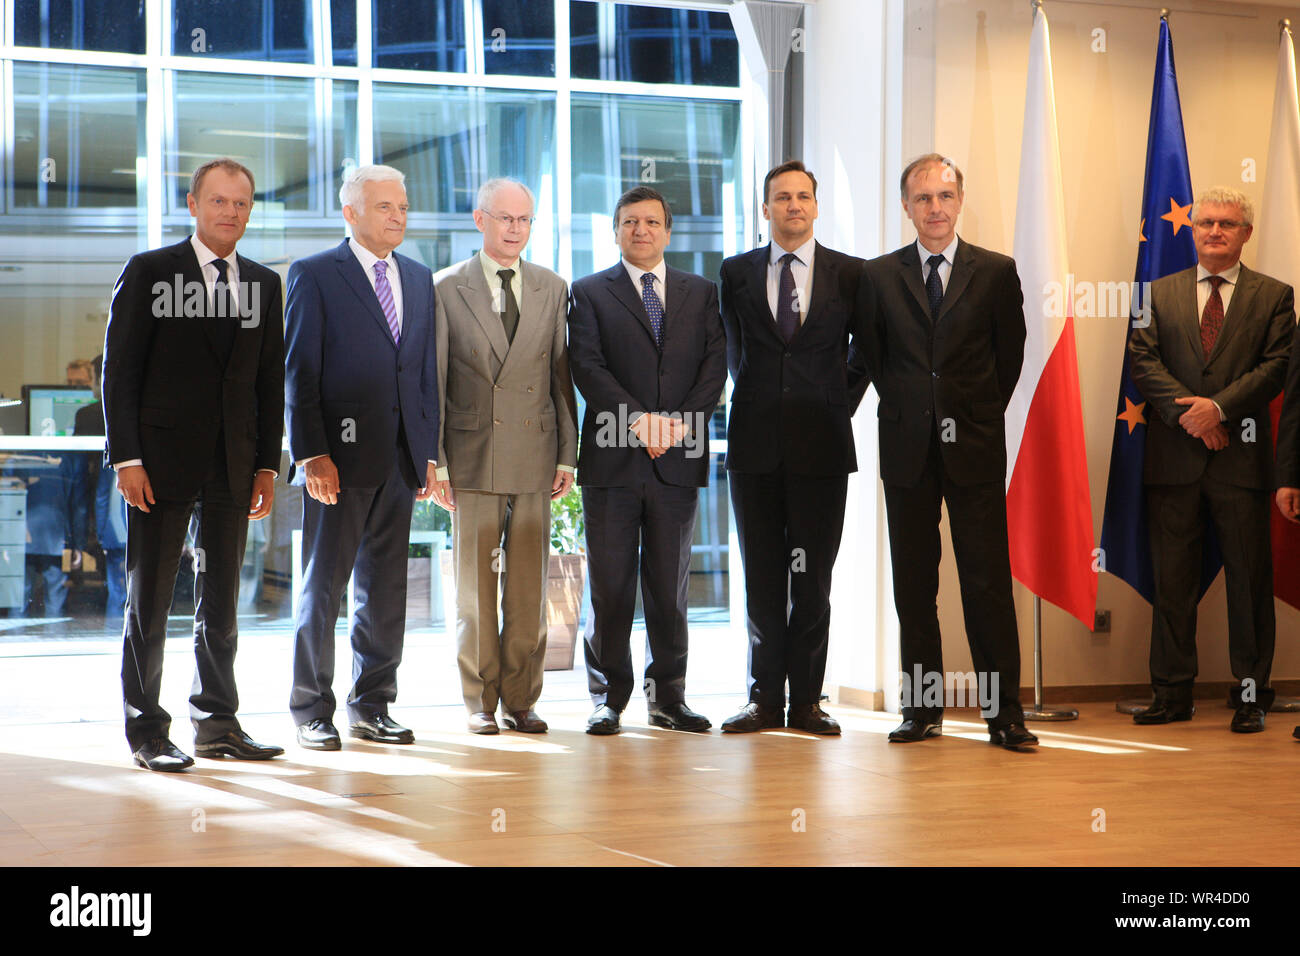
[722,160,868,734]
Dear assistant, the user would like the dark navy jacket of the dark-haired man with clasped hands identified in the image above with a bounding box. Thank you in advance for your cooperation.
[568,261,727,488]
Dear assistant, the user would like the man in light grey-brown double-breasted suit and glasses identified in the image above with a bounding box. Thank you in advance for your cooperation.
[433,179,577,734]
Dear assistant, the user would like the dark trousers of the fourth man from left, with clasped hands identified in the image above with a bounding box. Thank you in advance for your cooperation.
[582,479,699,713]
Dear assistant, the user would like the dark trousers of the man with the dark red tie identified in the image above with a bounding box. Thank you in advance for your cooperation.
[1147,475,1277,710]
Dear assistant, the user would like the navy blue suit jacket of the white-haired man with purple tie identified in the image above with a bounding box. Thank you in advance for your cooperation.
[285,239,438,488]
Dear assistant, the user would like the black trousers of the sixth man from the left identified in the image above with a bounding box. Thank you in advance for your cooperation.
[885,431,1024,727]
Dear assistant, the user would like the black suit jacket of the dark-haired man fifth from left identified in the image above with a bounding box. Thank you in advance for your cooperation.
[722,243,870,475]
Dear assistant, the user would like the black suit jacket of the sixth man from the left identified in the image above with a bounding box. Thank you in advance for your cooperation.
[865,239,1024,486]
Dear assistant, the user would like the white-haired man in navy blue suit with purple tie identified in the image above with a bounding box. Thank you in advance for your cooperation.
[285,166,438,750]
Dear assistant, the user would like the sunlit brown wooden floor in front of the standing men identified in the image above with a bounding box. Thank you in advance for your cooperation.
[0,697,1300,866]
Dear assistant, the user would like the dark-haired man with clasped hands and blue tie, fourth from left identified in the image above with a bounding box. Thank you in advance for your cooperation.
[568,186,727,734]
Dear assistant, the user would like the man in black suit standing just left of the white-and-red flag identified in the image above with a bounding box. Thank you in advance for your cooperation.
[865,153,1037,749]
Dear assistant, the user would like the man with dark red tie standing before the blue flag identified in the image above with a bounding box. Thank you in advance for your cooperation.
[1128,189,1296,734]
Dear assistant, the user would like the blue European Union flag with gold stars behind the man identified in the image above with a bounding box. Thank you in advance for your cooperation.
[1101,20,1222,601]
